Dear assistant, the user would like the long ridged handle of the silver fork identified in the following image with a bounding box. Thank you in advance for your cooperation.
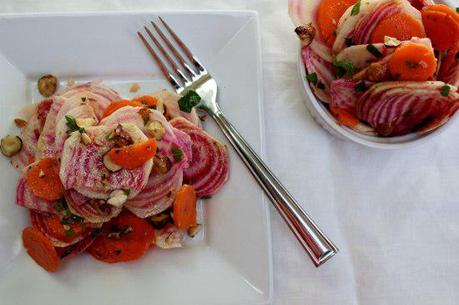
[211,109,338,267]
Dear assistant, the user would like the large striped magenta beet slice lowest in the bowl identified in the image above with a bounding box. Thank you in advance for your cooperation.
[356,81,459,136]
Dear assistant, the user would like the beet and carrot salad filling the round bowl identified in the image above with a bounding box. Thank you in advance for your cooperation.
[289,0,459,137]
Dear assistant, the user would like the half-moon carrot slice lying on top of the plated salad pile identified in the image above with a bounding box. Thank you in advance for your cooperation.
[108,138,157,169]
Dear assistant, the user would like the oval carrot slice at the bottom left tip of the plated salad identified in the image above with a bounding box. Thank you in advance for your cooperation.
[22,227,59,272]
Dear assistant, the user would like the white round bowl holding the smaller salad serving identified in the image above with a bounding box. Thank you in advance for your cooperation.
[297,47,457,149]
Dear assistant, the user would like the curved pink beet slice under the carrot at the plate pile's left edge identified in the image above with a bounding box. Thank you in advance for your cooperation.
[16,173,56,213]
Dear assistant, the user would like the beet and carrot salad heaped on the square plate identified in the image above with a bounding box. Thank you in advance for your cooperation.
[1,80,229,272]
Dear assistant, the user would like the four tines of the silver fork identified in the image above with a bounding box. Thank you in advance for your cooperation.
[137,17,207,92]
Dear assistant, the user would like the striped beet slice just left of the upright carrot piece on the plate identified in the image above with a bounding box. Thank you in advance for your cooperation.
[124,166,183,218]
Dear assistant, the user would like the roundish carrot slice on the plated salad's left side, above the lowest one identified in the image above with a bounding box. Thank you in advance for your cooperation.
[27,158,64,200]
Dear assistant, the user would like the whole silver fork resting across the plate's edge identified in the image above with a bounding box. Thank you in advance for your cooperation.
[137,17,338,267]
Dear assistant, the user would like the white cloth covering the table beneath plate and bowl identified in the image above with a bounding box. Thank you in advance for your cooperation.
[0,0,459,305]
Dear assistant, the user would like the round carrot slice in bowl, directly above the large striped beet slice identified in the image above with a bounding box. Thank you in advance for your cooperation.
[388,43,437,81]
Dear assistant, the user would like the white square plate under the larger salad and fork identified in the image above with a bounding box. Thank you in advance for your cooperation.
[0,12,272,305]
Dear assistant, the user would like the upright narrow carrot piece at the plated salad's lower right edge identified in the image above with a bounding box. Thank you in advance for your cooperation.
[173,184,196,229]
